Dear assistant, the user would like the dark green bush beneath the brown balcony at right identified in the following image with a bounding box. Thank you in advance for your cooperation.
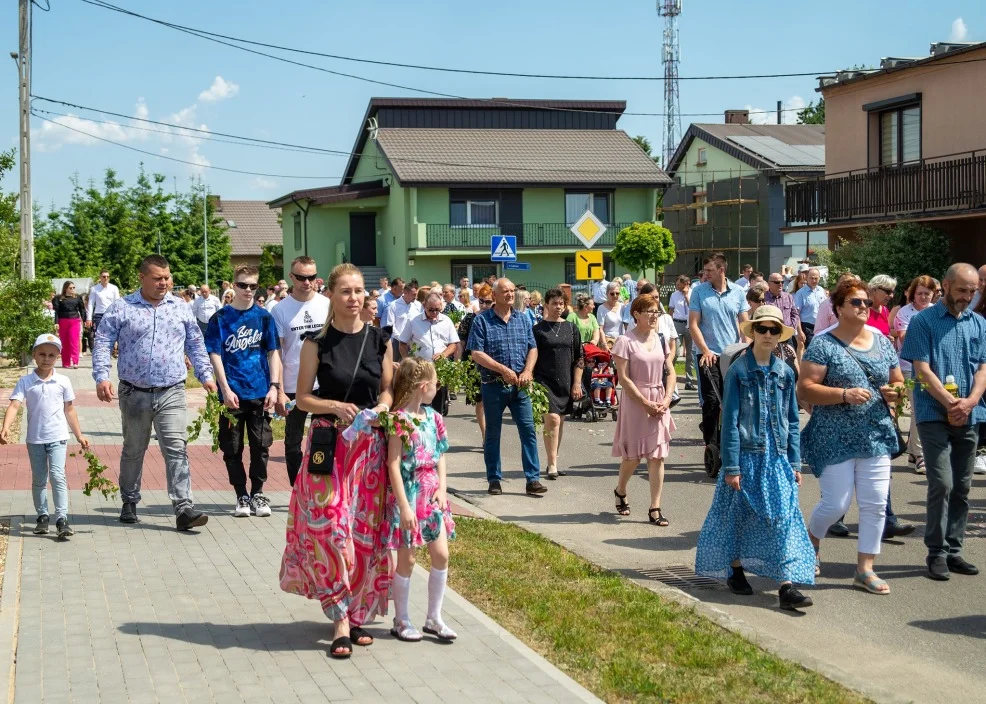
[819,223,952,288]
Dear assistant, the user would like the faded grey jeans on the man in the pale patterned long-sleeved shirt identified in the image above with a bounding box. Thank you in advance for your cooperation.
[120,383,192,514]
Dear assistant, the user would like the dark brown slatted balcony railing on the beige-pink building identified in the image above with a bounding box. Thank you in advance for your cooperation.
[786,151,986,225]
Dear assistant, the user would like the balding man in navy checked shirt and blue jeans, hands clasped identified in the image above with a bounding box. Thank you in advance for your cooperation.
[466,279,547,496]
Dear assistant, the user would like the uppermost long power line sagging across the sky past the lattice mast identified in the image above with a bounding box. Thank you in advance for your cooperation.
[82,0,844,81]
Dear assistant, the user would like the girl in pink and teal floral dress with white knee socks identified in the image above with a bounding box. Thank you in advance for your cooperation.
[386,357,456,642]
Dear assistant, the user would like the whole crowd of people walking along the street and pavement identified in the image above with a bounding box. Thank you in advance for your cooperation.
[0,253,986,657]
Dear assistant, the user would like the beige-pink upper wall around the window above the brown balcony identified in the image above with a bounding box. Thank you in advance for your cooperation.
[823,49,986,174]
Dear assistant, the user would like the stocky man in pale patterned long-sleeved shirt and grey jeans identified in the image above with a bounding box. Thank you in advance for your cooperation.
[92,254,216,530]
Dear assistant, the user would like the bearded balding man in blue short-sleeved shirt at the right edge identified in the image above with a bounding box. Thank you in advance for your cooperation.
[900,264,986,581]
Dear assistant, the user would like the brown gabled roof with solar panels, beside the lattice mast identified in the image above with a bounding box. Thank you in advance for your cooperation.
[668,123,825,174]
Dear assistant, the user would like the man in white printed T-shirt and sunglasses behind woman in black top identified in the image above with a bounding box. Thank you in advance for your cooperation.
[271,256,329,486]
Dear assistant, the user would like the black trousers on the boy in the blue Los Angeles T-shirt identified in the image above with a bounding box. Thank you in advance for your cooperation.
[219,398,274,496]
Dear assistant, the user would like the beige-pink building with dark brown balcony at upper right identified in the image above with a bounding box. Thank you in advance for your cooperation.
[784,43,986,262]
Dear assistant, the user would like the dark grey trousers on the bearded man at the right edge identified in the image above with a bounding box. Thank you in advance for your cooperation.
[918,421,979,557]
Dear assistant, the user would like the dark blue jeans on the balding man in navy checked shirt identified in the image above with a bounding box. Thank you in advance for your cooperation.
[483,382,541,483]
